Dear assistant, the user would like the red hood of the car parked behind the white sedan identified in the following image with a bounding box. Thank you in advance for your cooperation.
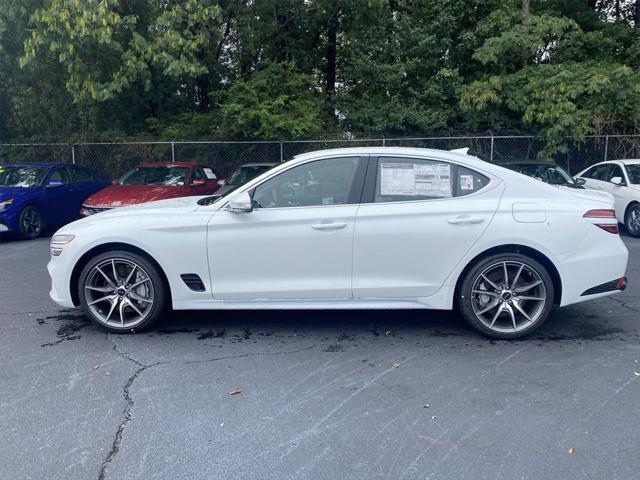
[84,185,184,207]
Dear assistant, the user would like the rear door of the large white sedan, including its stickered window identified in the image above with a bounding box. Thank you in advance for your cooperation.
[353,157,504,298]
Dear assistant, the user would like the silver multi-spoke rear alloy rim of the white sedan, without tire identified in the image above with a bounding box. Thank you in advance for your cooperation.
[471,261,547,333]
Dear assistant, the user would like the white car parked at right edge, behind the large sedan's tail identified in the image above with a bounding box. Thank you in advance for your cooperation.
[576,160,640,237]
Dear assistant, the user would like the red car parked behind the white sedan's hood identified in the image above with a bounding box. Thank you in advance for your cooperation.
[80,162,220,216]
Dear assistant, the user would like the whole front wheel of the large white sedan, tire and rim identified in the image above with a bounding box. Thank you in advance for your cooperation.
[78,250,168,333]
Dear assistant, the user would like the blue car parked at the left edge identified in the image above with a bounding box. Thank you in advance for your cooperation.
[0,163,110,239]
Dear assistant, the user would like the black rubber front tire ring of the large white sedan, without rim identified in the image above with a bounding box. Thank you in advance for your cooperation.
[78,250,168,333]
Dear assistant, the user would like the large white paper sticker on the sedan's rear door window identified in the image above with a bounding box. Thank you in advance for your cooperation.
[380,163,452,198]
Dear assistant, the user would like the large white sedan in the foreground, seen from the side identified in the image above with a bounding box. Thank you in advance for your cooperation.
[48,148,628,338]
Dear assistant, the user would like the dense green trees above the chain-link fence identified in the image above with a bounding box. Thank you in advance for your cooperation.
[0,0,640,153]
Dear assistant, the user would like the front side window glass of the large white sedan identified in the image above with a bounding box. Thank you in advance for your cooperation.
[253,157,359,208]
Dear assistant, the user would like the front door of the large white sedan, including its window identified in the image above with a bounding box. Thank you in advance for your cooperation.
[208,157,366,300]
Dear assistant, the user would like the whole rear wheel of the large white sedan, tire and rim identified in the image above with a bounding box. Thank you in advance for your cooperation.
[457,253,555,339]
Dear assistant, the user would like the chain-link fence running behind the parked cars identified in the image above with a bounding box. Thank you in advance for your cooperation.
[0,135,640,178]
